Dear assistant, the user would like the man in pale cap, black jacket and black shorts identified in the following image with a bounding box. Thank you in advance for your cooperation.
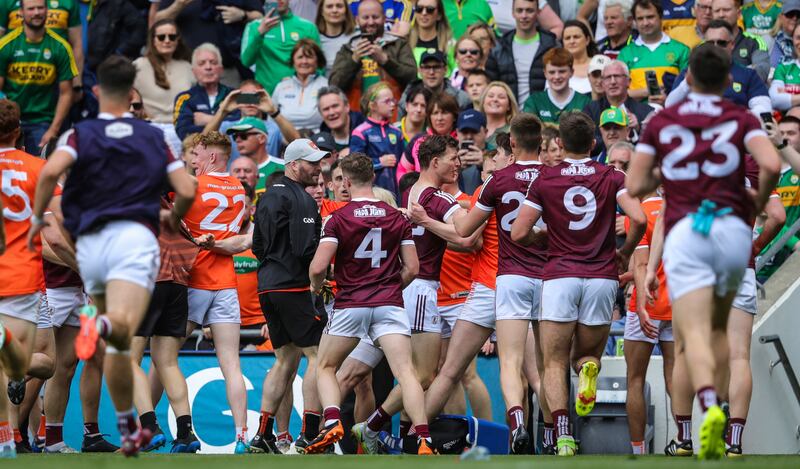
[250,139,330,454]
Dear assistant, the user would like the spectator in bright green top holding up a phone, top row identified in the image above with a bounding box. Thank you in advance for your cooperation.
[242,0,319,94]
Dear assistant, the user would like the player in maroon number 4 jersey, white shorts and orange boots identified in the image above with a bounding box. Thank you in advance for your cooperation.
[306,153,432,454]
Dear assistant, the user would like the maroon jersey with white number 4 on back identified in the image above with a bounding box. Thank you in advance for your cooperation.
[320,199,414,309]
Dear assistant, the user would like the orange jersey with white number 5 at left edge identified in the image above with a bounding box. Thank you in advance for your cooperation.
[0,148,45,296]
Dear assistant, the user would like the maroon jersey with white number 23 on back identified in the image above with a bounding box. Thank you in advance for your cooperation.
[636,93,766,233]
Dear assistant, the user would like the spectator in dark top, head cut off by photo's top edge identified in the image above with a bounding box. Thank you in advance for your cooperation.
[155,0,264,82]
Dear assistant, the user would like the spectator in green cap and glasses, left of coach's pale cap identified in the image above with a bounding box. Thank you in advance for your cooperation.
[227,117,285,197]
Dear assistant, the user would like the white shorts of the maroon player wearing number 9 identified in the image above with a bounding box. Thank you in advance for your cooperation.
[541,277,619,326]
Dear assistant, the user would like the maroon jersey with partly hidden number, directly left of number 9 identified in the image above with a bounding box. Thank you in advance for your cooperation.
[475,161,547,278]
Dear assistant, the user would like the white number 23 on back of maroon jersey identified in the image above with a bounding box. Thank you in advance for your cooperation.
[658,121,741,181]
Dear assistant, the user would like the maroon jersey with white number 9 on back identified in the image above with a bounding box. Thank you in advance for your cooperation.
[525,158,625,280]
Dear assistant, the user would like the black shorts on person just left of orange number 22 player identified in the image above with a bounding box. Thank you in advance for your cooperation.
[136,282,189,337]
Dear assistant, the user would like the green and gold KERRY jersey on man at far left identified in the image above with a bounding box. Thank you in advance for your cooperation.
[0,28,78,123]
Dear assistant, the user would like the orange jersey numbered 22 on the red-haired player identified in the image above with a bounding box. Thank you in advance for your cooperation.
[184,173,245,290]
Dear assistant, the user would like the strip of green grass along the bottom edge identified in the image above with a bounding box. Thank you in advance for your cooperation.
[0,454,800,469]
